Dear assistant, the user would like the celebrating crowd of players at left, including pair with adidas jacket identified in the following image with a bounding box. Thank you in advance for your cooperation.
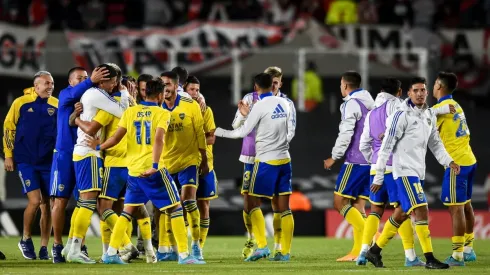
[4,63,296,264]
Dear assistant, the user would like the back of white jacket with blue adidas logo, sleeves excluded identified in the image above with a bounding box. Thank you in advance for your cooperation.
[255,96,290,162]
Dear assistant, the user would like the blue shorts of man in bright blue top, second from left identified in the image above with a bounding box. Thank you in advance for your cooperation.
[49,152,76,198]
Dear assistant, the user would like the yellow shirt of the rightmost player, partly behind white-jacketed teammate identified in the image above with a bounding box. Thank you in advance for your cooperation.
[433,95,476,166]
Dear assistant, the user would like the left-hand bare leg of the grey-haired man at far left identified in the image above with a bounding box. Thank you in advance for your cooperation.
[18,189,41,260]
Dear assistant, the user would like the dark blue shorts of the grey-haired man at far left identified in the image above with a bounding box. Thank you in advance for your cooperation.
[17,163,51,195]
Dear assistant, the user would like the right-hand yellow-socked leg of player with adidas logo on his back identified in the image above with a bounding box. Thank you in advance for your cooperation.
[270,195,294,262]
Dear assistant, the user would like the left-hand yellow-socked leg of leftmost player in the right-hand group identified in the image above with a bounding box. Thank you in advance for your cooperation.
[333,194,364,262]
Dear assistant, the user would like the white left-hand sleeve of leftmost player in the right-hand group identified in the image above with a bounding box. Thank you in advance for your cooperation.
[332,100,362,160]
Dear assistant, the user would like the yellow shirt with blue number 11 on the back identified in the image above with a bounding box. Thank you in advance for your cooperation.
[118,101,170,177]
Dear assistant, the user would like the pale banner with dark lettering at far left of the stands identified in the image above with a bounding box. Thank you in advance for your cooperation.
[0,23,49,77]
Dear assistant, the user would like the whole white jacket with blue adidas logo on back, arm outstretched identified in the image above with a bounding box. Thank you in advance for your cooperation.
[214,93,296,162]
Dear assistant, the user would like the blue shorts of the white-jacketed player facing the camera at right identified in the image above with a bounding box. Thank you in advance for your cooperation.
[396,177,427,214]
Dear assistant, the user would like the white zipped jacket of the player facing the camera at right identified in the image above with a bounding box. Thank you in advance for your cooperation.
[373,99,453,185]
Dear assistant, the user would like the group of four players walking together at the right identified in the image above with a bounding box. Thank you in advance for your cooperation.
[324,72,476,269]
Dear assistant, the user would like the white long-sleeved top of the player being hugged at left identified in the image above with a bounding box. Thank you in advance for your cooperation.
[73,87,129,157]
